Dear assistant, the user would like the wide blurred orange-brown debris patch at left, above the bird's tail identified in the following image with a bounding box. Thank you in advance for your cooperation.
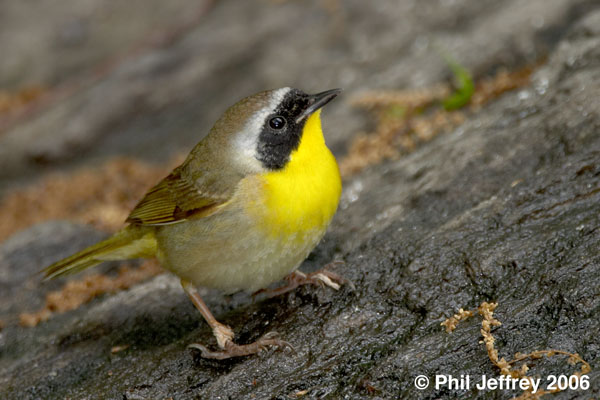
[0,158,181,241]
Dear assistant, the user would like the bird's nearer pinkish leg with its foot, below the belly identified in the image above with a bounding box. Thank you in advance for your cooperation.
[181,279,294,360]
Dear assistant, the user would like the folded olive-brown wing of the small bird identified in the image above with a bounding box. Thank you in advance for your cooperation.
[126,167,228,225]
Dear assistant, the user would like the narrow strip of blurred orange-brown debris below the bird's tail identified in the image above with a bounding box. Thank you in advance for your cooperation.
[19,260,163,327]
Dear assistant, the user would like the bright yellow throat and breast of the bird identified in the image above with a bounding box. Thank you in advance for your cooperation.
[255,110,342,236]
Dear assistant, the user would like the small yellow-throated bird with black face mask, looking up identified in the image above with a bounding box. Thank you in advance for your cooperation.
[44,88,342,359]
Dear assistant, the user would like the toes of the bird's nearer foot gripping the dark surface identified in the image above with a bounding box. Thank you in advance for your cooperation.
[188,332,294,360]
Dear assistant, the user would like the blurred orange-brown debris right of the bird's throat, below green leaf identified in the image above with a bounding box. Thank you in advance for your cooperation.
[340,65,537,176]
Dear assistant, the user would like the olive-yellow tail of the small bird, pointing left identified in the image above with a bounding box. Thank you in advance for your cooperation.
[42,226,156,279]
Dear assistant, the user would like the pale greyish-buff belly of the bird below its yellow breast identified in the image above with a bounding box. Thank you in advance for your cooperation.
[150,192,326,292]
